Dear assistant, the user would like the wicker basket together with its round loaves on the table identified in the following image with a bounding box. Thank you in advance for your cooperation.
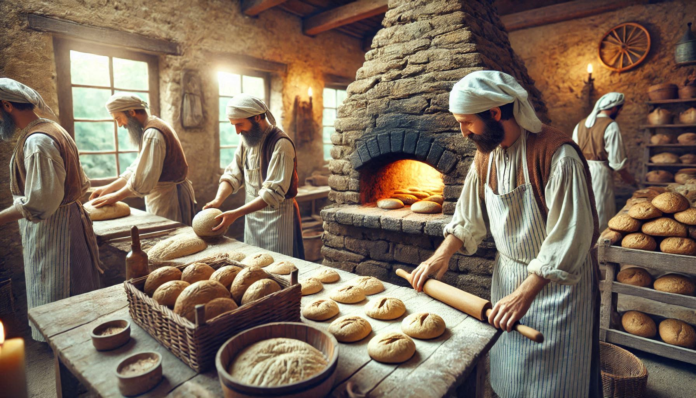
[124,253,301,372]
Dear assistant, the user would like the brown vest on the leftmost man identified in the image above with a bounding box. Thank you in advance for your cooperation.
[10,119,82,205]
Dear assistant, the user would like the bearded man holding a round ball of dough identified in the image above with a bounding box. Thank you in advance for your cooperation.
[204,94,304,259]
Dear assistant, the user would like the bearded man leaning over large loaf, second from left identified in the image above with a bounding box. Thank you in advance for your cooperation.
[90,93,196,225]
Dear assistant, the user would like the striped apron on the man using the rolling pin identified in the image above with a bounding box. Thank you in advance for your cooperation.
[485,134,594,398]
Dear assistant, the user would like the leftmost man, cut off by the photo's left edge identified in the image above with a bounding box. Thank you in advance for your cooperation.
[0,78,102,341]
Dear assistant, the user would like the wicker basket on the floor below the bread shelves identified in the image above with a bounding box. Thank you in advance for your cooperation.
[599,341,648,398]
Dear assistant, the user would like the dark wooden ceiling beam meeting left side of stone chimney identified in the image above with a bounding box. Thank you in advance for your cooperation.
[303,0,389,36]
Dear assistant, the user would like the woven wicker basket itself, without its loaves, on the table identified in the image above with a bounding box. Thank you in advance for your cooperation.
[124,254,302,372]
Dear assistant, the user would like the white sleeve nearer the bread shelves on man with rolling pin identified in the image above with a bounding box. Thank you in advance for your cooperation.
[527,145,594,285]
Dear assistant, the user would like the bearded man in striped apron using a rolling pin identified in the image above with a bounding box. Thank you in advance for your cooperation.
[412,71,601,397]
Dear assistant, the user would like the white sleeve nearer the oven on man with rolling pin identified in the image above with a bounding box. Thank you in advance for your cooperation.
[444,163,488,256]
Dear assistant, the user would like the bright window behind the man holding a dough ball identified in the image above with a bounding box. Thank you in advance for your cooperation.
[218,72,270,169]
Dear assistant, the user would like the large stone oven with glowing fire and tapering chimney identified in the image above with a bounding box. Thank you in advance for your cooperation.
[322,0,546,297]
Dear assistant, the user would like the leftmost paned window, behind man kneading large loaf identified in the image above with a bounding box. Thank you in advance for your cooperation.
[56,41,159,185]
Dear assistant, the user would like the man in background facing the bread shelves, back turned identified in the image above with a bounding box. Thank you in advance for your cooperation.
[573,93,636,231]
